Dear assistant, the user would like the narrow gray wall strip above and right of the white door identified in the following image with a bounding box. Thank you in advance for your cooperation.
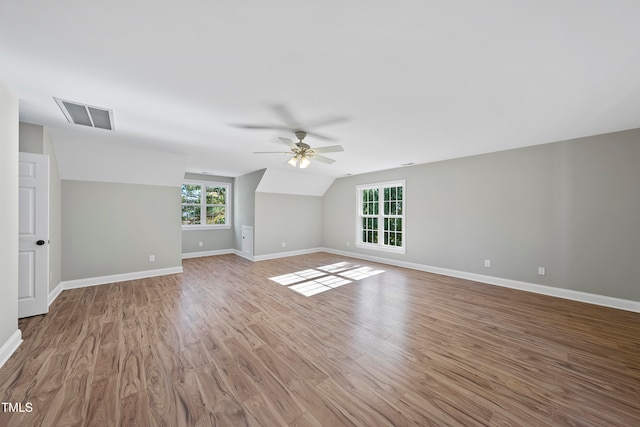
[20,123,62,291]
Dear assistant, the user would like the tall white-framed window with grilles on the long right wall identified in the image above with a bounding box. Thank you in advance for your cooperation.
[356,180,406,253]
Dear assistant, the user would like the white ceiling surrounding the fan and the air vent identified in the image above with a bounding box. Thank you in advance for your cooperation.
[0,0,640,177]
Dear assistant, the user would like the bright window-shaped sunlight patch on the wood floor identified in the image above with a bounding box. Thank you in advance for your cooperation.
[269,262,384,297]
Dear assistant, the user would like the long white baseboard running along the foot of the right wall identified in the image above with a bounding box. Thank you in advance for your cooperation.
[322,248,640,313]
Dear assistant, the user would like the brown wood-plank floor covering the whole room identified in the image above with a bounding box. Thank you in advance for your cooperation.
[0,253,640,426]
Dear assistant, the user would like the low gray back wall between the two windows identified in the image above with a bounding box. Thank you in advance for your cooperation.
[254,193,323,256]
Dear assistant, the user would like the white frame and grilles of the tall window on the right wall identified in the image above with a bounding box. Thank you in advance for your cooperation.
[355,179,407,254]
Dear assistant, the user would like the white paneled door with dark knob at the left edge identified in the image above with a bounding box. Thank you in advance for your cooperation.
[18,153,49,317]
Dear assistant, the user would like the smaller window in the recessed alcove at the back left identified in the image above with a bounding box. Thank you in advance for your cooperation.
[182,181,231,228]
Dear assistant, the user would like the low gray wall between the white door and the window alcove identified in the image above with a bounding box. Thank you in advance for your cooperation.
[62,180,182,280]
